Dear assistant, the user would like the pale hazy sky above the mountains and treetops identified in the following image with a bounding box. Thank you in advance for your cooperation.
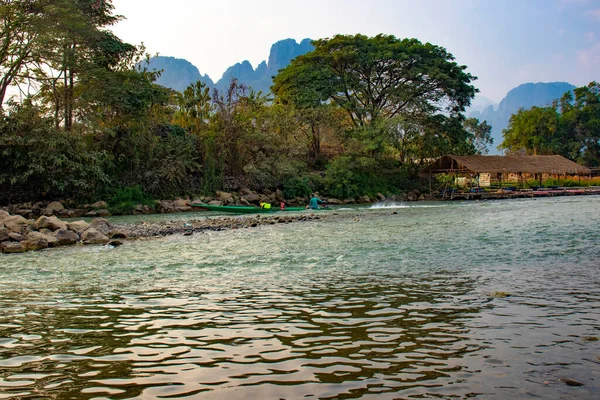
[112,0,600,102]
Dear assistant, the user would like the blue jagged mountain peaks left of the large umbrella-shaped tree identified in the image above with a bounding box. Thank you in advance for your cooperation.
[148,39,313,93]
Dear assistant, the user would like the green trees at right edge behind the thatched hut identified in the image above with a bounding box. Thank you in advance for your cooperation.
[500,82,600,167]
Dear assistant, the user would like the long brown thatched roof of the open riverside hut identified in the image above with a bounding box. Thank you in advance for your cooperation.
[423,155,591,175]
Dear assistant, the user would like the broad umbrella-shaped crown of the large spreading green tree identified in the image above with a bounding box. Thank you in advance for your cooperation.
[272,35,477,126]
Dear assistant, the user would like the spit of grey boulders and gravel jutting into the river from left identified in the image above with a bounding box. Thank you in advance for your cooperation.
[0,210,324,253]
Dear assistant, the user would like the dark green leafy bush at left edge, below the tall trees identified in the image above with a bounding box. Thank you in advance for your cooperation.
[0,103,110,203]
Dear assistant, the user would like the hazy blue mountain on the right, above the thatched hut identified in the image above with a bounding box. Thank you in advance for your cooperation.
[467,82,575,154]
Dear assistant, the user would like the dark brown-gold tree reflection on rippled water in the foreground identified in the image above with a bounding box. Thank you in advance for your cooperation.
[0,277,485,399]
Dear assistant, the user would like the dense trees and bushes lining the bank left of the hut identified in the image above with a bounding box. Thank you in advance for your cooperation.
[0,0,491,203]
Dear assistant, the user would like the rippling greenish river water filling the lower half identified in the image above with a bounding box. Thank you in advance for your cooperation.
[0,196,600,399]
